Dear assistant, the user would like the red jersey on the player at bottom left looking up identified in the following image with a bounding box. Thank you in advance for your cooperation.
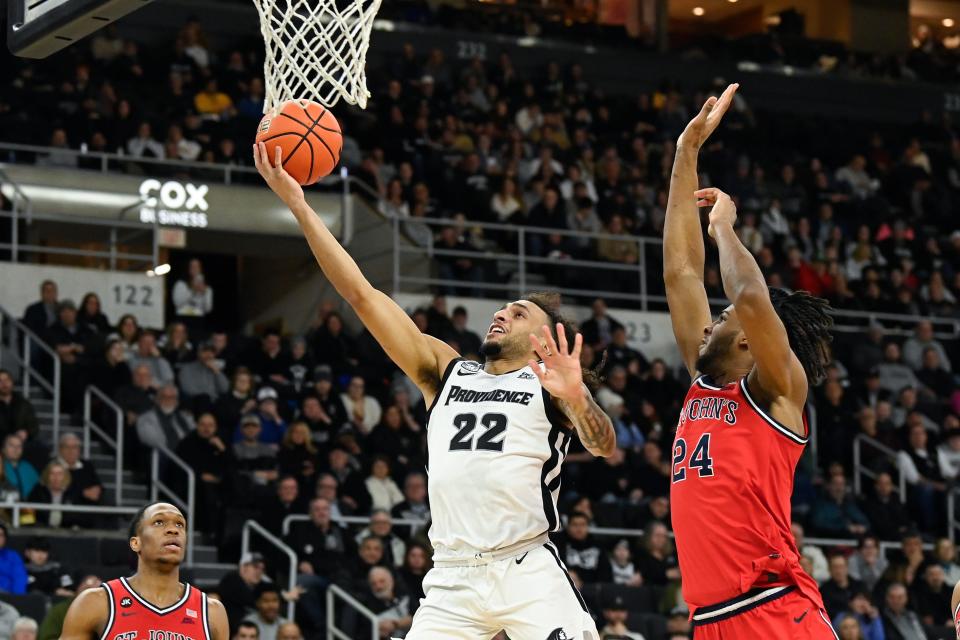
[101,578,213,640]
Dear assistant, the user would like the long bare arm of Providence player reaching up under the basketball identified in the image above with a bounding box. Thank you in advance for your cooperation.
[253,142,457,406]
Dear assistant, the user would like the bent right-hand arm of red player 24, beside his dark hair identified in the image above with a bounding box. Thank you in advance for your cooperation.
[695,188,807,416]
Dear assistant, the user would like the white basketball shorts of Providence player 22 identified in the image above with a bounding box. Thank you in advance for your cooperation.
[406,542,600,640]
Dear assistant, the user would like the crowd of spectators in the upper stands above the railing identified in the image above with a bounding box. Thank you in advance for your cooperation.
[0,21,960,323]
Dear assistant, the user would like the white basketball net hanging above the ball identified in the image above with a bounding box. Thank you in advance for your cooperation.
[253,0,380,113]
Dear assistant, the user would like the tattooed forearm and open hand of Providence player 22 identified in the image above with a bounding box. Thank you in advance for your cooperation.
[529,323,617,458]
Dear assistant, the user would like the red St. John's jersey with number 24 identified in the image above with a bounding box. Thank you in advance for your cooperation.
[670,376,823,620]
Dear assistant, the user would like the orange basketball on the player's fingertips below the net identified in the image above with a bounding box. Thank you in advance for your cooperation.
[257,100,343,185]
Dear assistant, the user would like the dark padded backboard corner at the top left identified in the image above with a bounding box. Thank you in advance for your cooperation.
[7,0,153,58]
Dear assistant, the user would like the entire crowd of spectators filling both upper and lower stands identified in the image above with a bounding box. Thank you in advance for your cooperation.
[0,8,960,640]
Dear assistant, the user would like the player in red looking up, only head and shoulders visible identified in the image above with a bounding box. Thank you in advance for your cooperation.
[60,502,230,640]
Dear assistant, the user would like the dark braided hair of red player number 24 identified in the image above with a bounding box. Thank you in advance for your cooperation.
[770,287,833,386]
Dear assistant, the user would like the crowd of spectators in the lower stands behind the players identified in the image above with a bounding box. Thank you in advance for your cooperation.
[0,264,960,639]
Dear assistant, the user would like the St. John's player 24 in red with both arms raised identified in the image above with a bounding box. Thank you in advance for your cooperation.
[663,85,836,640]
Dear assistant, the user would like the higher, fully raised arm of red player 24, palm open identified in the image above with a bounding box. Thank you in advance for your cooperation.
[663,84,740,376]
